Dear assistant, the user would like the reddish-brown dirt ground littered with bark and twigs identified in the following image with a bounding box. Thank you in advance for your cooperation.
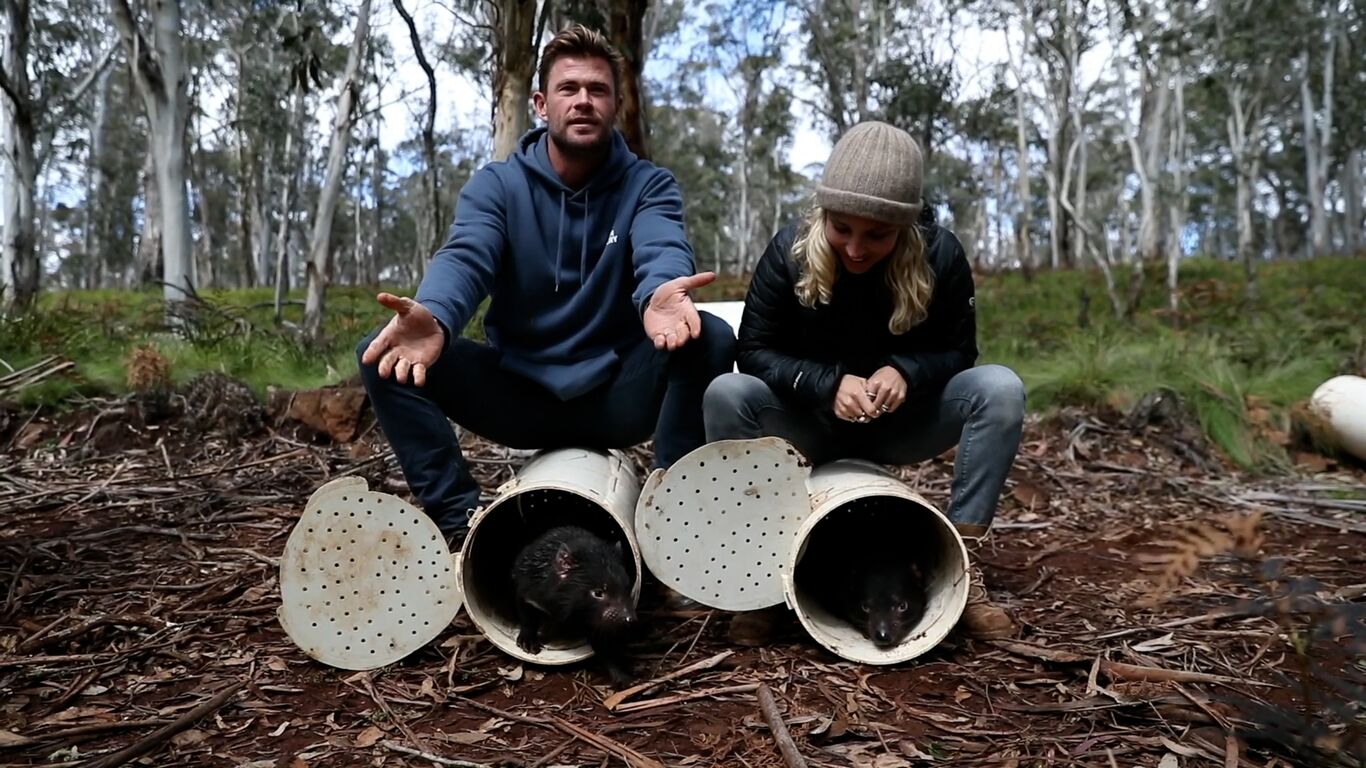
[0,388,1366,768]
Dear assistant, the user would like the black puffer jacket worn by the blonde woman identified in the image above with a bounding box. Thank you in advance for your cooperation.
[736,215,977,410]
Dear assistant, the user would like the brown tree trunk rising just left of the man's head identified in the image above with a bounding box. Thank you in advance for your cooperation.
[493,0,537,160]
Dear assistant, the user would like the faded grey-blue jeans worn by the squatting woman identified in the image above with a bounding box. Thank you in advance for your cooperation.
[702,365,1025,526]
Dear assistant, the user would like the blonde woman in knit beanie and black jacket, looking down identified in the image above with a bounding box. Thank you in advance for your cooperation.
[703,122,1025,641]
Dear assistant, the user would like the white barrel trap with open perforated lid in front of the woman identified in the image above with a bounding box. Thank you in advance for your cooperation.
[635,437,968,664]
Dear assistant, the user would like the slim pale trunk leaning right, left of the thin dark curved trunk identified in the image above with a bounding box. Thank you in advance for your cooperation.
[303,0,370,342]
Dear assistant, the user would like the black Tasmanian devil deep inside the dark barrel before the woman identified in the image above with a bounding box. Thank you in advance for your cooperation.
[796,514,928,649]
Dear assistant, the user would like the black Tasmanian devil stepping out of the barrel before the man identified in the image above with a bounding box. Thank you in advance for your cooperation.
[512,525,638,686]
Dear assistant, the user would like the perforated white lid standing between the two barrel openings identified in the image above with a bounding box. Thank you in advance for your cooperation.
[635,437,811,611]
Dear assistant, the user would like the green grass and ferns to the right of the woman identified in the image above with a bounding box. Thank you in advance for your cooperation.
[977,258,1366,467]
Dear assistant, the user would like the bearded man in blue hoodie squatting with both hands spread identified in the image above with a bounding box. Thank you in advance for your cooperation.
[357,26,735,538]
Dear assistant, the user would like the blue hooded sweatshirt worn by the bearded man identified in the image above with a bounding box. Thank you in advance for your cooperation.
[417,127,694,400]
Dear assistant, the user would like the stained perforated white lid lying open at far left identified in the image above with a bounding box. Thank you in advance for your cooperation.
[277,477,460,670]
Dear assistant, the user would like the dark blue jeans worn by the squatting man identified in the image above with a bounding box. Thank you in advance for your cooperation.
[357,312,735,536]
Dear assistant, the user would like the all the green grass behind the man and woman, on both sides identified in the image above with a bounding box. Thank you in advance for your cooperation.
[0,258,1366,467]
